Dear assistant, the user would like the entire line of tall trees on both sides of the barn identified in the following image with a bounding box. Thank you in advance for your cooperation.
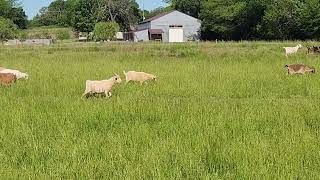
[30,0,320,40]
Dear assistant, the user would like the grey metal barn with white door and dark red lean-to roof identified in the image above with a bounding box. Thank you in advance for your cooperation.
[126,10,201,42]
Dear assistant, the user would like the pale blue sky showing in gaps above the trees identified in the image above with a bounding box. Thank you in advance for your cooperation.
[21,0,166,19]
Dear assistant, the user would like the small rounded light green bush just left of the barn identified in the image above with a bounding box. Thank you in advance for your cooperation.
[94,22,120,40]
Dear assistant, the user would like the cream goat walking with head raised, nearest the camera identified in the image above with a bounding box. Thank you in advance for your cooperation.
[82,74,121,98]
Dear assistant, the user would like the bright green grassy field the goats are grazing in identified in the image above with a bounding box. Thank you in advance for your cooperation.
[0,42,320,179]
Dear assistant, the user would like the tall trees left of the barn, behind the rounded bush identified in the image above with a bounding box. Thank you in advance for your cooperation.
[31,0,142,32]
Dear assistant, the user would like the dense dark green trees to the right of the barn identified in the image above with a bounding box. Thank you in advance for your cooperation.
[164,0,320,40]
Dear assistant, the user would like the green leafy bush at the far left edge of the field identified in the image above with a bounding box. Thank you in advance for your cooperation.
[0,17,17,43]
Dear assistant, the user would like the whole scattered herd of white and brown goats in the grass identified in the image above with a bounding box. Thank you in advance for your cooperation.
[0,44,320,98]
